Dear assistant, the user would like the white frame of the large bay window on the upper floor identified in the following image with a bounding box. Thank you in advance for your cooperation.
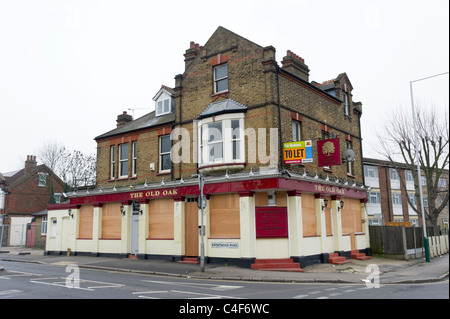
[197,113,245,166]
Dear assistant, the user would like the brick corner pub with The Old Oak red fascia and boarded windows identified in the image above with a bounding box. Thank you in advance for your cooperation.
[46,27,370,270]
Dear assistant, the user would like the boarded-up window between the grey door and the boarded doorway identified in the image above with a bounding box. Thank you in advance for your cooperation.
[148,198,174,239]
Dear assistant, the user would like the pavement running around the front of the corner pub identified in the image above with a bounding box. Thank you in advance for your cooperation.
[0,247,449,284]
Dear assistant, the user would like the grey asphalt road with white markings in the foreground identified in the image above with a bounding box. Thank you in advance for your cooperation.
[0,261,449,304]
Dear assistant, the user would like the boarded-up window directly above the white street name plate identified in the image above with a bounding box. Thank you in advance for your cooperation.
[209,194,241,238]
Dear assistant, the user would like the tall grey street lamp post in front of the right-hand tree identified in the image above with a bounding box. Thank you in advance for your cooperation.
[409,72,448,262]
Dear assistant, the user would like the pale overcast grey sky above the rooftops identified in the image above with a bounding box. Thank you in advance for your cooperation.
[0,0,449,172]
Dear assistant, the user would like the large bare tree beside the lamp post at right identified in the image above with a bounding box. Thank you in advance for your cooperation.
[378,109,449,226]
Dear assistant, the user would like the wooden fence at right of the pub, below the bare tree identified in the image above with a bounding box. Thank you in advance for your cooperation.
[369,226,449,260]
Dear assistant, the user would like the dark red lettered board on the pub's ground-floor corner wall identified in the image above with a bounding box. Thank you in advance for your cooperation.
[256,207,288,238]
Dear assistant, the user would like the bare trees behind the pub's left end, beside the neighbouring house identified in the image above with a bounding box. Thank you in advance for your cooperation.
[38,141,96,189]
